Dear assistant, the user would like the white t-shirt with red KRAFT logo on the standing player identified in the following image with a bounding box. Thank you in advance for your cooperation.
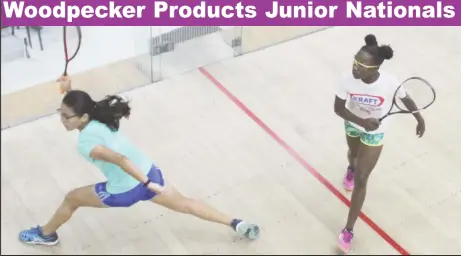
[336,71,406,134]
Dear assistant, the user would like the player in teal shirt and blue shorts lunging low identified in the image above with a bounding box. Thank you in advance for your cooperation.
[19,80,259,245]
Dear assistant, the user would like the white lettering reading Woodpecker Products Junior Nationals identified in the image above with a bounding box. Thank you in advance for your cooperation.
[6,0,450,23]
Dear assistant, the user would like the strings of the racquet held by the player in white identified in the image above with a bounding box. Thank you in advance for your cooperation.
[395,79,435,111]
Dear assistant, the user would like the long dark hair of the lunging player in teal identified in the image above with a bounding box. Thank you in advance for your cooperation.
[62,90,131,131]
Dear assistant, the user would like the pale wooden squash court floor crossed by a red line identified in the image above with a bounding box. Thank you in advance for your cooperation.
[1,27,461,255]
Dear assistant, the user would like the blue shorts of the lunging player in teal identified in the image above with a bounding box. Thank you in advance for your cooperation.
[94,165,165,207]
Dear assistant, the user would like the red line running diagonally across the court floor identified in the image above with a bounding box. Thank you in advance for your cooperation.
[199,67,410,255]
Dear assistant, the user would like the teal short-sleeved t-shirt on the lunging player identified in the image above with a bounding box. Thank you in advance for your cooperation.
[78,120,153,194]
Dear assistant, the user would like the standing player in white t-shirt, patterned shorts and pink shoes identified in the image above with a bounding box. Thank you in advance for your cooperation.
[334,35,425,253]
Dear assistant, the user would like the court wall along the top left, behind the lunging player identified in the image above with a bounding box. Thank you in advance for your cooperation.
[1,26,327,129]
